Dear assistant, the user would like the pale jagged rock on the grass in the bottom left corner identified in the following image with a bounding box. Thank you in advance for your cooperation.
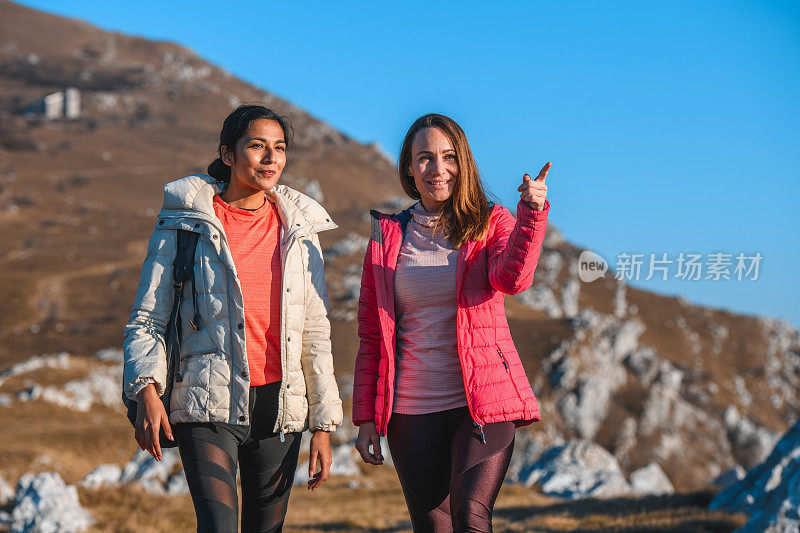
[10,472,93,533]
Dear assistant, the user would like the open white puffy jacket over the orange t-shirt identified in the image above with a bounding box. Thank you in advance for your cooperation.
[123,174,342,434]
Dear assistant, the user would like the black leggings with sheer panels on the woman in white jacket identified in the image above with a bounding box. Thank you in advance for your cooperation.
[174,382,300,533]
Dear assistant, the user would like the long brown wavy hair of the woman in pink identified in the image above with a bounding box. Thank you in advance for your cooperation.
[397,113,491,247]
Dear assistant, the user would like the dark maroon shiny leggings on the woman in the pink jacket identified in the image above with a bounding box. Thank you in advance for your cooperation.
[387,407,514,533]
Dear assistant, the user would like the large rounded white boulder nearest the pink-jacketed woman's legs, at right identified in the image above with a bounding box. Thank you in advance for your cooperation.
[520,440,631,499]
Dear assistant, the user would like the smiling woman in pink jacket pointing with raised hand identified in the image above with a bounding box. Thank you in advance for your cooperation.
[353,114,550,532]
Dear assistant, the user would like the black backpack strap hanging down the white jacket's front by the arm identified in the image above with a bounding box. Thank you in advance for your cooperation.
[166,229,200,382]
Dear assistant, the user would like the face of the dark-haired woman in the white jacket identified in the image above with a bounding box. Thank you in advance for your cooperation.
[221,119,286,194]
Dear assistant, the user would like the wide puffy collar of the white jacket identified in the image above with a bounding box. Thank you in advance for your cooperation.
[158,174,338,234]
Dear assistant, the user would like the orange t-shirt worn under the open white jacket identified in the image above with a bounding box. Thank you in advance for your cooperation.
[214,195,281,387]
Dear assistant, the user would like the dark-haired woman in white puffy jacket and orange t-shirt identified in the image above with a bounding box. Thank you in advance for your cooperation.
[123,105,342,532]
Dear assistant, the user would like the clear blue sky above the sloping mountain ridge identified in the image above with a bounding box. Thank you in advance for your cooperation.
[22,0,800,326]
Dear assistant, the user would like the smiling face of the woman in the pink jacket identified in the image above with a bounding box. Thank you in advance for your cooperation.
[408,128,458,211]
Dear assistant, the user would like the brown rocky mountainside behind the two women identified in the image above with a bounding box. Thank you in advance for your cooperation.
[0,0,800,528]
